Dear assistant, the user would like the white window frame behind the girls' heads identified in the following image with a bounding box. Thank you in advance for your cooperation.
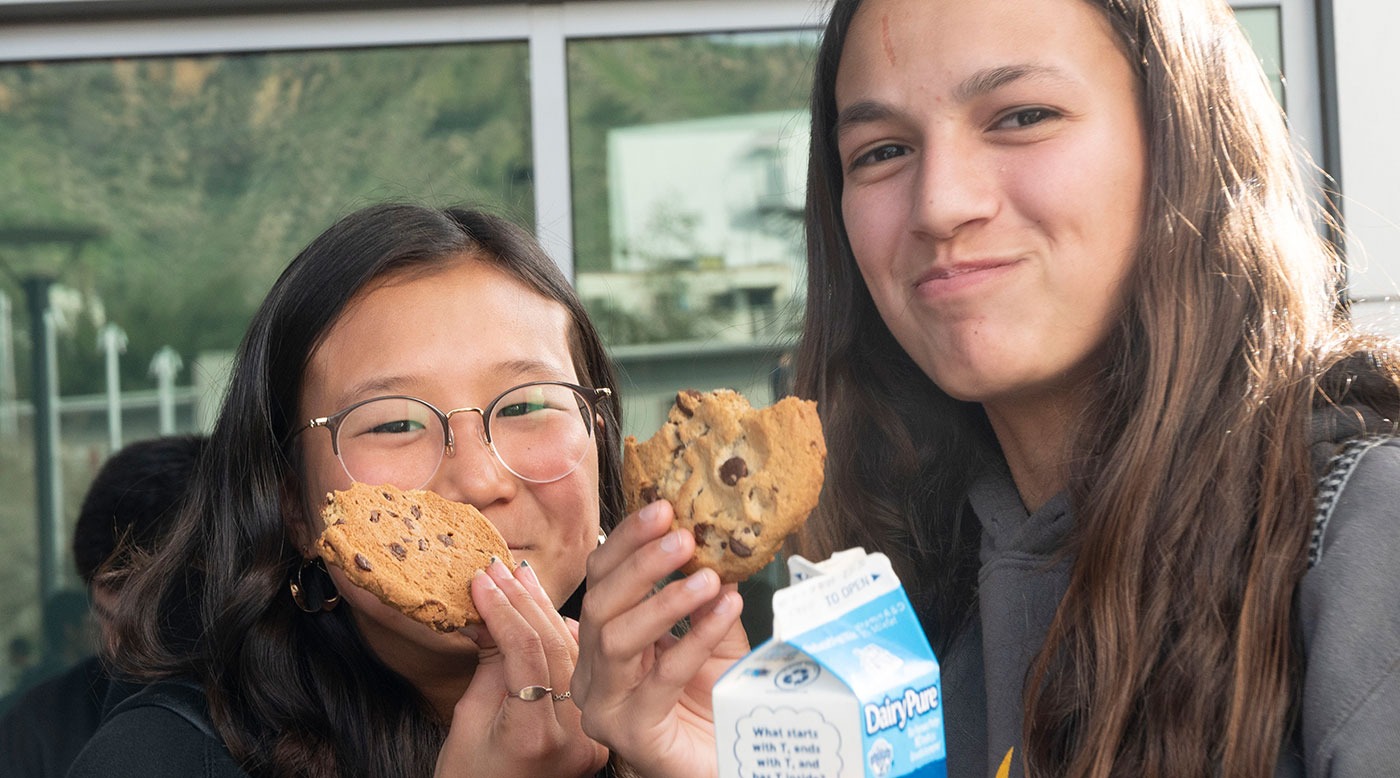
[0,0,1324,278]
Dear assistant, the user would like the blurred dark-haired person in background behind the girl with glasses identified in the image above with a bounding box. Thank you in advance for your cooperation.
[0,437,204,778]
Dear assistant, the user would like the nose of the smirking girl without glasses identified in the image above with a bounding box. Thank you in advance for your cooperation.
[910,136,1000,241]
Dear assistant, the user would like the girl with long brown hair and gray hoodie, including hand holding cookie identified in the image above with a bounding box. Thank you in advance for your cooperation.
[575,0,1400,778]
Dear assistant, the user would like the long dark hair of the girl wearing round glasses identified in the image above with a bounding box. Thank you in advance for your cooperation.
[112,204,623,777]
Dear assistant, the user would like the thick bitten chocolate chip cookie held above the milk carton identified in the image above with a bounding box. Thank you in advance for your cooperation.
[622,389,826,584]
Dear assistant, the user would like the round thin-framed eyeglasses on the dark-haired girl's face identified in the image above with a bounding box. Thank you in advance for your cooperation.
[293,381,612,490]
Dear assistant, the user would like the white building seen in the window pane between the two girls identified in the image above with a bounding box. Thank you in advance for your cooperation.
[575,111,809,343]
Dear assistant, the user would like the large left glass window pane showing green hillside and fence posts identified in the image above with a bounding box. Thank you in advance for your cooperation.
[0,42,533,693]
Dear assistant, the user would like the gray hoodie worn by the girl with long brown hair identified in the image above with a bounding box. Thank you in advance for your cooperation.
[939,414,1400,778]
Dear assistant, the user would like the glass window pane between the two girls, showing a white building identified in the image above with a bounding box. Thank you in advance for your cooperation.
[568,32,818,437]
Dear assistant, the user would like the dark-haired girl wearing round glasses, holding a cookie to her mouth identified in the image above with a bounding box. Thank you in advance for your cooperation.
[70,206,622,777]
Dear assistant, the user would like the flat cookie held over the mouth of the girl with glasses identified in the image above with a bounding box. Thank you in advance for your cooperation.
[316,483,515,632]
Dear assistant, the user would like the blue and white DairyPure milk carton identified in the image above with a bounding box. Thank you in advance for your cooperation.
[714,549,948,778]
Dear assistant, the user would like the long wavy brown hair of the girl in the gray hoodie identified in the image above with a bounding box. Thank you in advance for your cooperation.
[798,0,1400,778]
